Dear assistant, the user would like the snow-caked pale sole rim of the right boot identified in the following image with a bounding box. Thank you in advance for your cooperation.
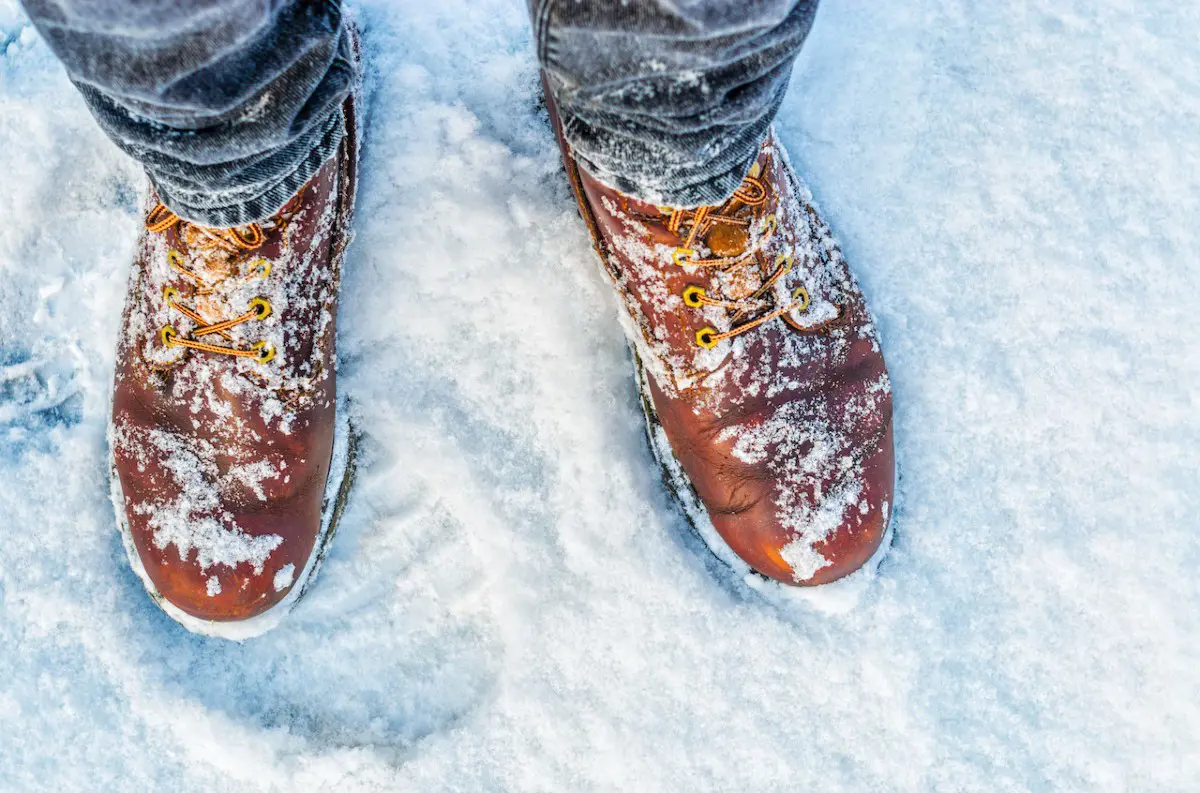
[630,348,895,614]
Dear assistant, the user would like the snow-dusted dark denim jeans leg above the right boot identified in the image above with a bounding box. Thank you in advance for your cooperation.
[530,0,817,206]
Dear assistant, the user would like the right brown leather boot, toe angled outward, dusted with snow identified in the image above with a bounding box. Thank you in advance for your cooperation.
[547,92,894,585]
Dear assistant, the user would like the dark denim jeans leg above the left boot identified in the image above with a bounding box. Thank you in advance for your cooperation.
[24,0,354,227]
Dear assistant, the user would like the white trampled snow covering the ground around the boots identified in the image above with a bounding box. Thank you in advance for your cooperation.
[0,0,1200,793]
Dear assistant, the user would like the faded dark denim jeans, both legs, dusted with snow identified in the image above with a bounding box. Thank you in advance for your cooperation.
[24,0,817,226]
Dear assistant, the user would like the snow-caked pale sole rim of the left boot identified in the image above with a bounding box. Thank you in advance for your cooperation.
[109,405,358,642]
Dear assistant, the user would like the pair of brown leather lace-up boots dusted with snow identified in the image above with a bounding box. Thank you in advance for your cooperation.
[110,86,894,638]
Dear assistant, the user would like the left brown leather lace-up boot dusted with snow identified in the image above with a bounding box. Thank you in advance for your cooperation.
[109,101,358,638]
